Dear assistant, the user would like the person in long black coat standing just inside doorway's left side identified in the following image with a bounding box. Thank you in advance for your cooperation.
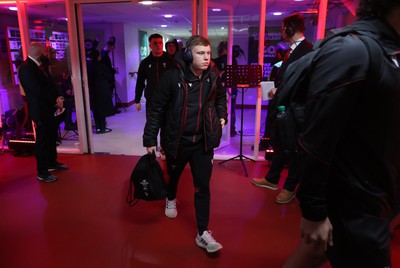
[87,50,115,134]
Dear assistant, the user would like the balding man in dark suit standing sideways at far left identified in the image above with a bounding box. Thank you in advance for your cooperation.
[18,42,68,182]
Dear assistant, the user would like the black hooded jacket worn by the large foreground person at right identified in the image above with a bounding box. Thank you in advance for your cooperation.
[297,19,400,221]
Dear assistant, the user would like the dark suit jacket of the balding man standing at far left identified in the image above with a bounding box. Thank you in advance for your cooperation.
[18,58,61,123]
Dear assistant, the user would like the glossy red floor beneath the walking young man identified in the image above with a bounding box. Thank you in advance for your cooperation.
[0,153,400,268]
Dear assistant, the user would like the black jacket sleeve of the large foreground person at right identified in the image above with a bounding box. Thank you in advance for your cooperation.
[297,36,369,221]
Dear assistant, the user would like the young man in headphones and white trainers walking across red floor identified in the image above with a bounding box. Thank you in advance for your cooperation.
[143,35,227,253]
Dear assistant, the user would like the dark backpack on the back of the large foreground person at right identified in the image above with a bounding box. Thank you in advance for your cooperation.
[271,26,380,154]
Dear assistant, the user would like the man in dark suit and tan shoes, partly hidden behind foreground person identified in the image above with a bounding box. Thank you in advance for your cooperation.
[252,14,313,204]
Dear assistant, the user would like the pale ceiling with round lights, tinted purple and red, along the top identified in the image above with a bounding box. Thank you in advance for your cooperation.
[0,0,350,37]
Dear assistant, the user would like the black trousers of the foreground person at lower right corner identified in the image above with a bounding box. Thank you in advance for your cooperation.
[327,206,392,268]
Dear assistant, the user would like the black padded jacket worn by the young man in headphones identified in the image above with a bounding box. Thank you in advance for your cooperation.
[143,56,228,156]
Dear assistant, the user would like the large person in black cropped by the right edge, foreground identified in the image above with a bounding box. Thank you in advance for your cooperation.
[287,0,400,268]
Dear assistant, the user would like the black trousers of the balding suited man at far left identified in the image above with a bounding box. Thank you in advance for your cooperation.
[35,117,58,175]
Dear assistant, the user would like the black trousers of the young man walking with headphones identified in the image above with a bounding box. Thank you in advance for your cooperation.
[166,143,214,235]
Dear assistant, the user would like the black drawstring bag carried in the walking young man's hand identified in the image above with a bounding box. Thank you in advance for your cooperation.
[126,152,167,207]
